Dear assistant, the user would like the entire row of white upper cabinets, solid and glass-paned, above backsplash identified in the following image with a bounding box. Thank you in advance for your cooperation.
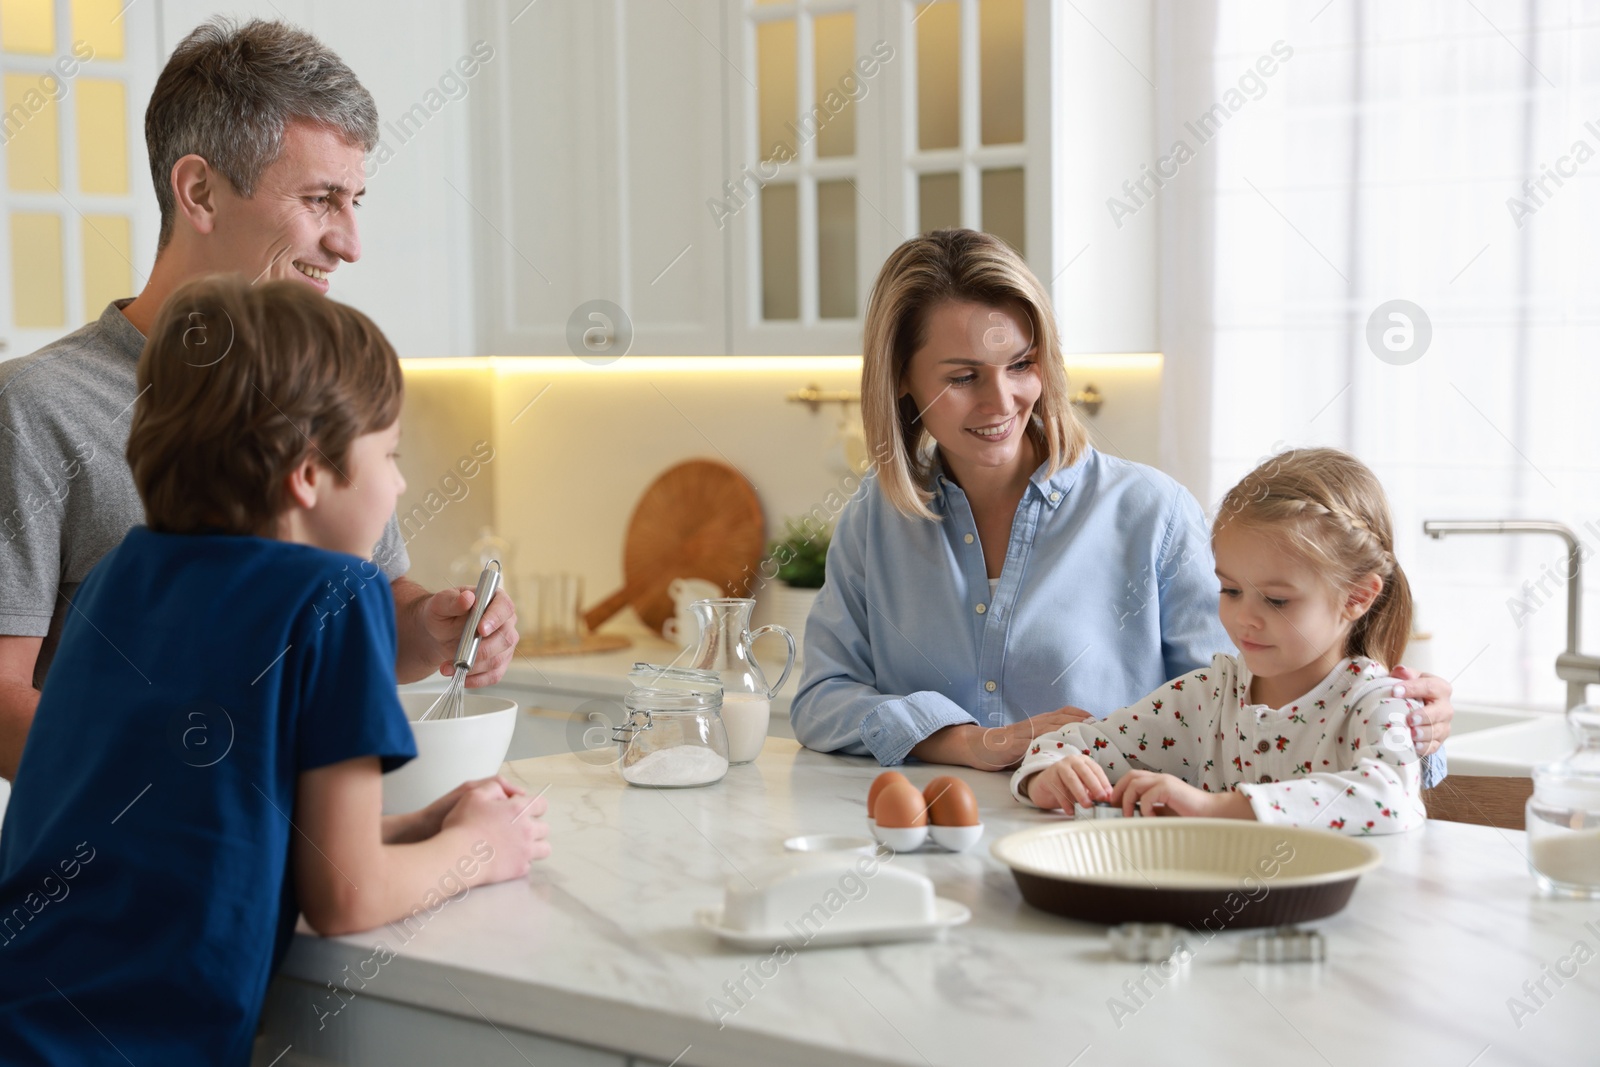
[469,0,1157,362]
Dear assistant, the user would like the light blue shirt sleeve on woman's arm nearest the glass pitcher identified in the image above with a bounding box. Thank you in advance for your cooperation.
[789,501,976,766]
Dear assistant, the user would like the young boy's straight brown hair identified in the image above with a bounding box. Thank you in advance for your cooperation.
[128,275,403,536]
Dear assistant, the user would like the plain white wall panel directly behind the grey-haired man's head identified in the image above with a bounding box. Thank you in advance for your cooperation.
[152,0,476,355]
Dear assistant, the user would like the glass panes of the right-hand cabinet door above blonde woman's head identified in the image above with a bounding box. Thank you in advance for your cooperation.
[904,0,1024,256]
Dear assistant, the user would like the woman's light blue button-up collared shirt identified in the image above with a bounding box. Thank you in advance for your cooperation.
[790,448,1234,766]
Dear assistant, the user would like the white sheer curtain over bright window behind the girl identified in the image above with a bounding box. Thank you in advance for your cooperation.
[1157,0,1600,709]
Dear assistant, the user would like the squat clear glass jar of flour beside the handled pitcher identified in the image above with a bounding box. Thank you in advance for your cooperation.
[611,664,728,789]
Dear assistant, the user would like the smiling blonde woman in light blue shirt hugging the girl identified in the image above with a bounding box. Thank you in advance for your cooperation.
[790,230,1453,784]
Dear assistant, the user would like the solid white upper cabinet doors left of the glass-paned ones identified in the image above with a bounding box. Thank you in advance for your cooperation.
[469,0,728,358]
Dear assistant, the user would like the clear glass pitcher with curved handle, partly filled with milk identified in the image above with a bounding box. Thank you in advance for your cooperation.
[688,597,795,763]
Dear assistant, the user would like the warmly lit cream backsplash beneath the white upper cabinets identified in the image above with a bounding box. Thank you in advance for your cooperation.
[400,357,1160,632]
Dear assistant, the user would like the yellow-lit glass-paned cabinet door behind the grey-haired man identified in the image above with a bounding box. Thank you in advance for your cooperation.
[0,0,157,358]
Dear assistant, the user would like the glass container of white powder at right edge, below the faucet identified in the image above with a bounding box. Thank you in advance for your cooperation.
[1526,704,1600,897]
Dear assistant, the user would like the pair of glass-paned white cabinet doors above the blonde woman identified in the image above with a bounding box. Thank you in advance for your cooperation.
[729,0,1051,352]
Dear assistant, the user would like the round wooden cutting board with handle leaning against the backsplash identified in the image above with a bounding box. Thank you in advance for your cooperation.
[584,459,766,633]
